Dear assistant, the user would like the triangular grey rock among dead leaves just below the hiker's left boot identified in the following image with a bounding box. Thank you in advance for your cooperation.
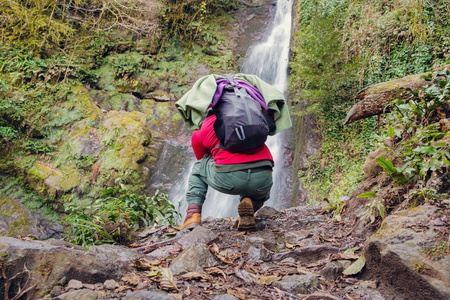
[170,244,218,275]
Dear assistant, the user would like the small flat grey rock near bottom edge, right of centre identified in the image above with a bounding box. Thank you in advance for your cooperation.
[272,274,319,294]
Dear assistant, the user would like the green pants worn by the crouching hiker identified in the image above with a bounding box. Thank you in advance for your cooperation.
[186,156,273,205]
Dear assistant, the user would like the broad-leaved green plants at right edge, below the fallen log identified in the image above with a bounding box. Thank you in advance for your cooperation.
[377,70,450,197]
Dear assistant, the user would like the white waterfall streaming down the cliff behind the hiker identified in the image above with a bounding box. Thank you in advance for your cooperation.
[169,0,293,219]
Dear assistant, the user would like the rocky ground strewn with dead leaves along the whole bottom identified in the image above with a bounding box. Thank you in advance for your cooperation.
[0,202,450,300]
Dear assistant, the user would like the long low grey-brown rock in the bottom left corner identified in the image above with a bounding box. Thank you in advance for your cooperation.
[0,237,140,299]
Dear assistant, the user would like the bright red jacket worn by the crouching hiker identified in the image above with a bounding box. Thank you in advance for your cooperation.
[192,115,273,165]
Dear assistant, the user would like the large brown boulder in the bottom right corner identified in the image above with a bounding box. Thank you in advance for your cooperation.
[364,205,450,299]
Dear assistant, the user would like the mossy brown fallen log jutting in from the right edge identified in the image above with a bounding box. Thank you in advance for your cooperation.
[343,65,450,125]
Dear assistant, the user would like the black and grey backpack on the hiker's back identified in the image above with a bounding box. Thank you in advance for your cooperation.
[213,75,276,153]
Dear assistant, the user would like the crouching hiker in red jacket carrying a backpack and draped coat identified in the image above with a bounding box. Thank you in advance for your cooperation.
[176,74,291,231]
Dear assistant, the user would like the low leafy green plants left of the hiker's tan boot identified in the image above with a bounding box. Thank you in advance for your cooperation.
[63,188,178,247]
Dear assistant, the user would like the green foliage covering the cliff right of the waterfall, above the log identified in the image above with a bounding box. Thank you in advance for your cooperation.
[289,0,450,201]
